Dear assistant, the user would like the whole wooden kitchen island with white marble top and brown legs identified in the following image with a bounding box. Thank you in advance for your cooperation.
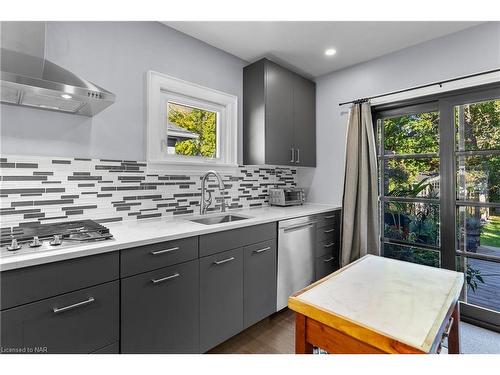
[288,255,464,354]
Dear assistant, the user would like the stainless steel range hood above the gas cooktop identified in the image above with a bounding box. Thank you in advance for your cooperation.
[0,22,115,116]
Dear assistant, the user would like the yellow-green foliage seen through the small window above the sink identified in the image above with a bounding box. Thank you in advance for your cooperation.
[168,103,217,158]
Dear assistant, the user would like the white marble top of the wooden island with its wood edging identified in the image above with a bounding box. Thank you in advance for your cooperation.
[289,255,464,352]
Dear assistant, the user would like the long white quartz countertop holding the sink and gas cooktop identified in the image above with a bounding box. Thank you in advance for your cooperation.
[0,203,340,271]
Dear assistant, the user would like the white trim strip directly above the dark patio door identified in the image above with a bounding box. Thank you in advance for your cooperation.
[370,72,500,106]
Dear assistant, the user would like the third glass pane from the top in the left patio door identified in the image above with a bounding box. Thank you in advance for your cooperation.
[384,202,439,246]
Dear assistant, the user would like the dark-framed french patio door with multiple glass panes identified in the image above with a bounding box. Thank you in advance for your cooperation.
[374,85,500,330]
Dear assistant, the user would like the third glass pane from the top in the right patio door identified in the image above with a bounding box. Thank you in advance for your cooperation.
[457,206,500,257]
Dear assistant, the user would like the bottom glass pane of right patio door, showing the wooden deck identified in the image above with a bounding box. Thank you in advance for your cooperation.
[457,257,500,312]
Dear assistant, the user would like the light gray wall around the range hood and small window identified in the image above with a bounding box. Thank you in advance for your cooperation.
[0,22,246,160]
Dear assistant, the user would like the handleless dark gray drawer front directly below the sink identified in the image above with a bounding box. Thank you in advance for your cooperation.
[200,223,277,257]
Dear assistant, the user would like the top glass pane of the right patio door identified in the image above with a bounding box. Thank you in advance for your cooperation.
[454,99,500,151]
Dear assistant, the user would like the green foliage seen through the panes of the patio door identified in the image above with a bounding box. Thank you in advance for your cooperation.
[382,100,500,292]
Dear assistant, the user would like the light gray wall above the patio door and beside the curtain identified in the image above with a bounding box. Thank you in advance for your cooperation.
[298,22,500,203]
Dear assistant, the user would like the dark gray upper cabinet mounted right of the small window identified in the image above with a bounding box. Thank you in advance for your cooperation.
[243,59,316,167]
